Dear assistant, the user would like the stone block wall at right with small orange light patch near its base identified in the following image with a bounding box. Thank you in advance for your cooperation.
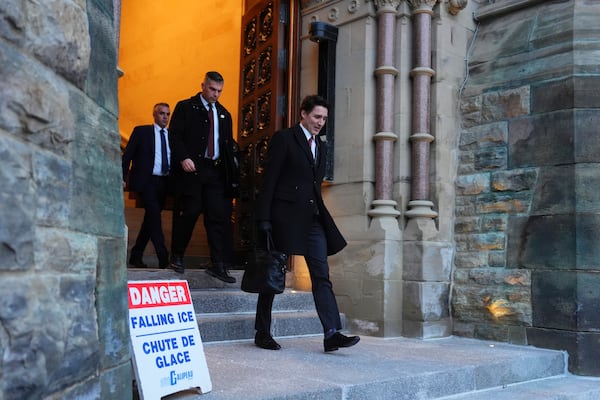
[452,0,600,375]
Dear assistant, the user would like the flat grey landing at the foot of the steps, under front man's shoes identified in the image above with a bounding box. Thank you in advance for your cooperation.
[157,335,600,400]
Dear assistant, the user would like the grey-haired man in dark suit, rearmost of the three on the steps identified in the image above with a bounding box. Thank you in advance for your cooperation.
[122,103,171,268]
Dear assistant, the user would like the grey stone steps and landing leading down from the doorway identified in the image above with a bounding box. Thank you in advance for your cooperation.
[128,269,600,400]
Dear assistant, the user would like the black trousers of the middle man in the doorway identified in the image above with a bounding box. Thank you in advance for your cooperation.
[171,164,233,265]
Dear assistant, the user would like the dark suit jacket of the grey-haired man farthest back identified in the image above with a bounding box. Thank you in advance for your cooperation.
[122,125,161,192]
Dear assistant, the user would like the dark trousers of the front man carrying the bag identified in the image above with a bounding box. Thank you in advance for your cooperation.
[254,220,342,333]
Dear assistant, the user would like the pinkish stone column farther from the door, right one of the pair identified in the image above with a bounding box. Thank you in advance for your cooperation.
[406,0,438,218]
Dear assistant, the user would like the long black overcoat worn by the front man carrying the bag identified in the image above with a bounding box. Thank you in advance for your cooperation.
[256,125,346,255]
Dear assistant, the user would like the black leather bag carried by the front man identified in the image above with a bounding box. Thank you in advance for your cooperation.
[241,234,288,294]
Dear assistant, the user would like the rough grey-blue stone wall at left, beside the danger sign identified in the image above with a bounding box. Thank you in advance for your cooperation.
[0,0,131,400]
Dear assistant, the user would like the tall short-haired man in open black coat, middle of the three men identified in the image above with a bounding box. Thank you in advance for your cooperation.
[169,71,239,283]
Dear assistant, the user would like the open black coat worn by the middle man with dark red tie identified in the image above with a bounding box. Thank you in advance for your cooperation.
[169,93,239,195]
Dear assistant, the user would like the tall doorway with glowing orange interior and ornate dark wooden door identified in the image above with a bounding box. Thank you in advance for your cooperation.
[119,0,298,268]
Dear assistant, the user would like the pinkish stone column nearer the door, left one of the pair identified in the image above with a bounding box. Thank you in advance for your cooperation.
[369,0,400,218]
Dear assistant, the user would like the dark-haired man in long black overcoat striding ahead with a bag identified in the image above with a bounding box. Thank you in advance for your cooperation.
[254,95,360,352]
